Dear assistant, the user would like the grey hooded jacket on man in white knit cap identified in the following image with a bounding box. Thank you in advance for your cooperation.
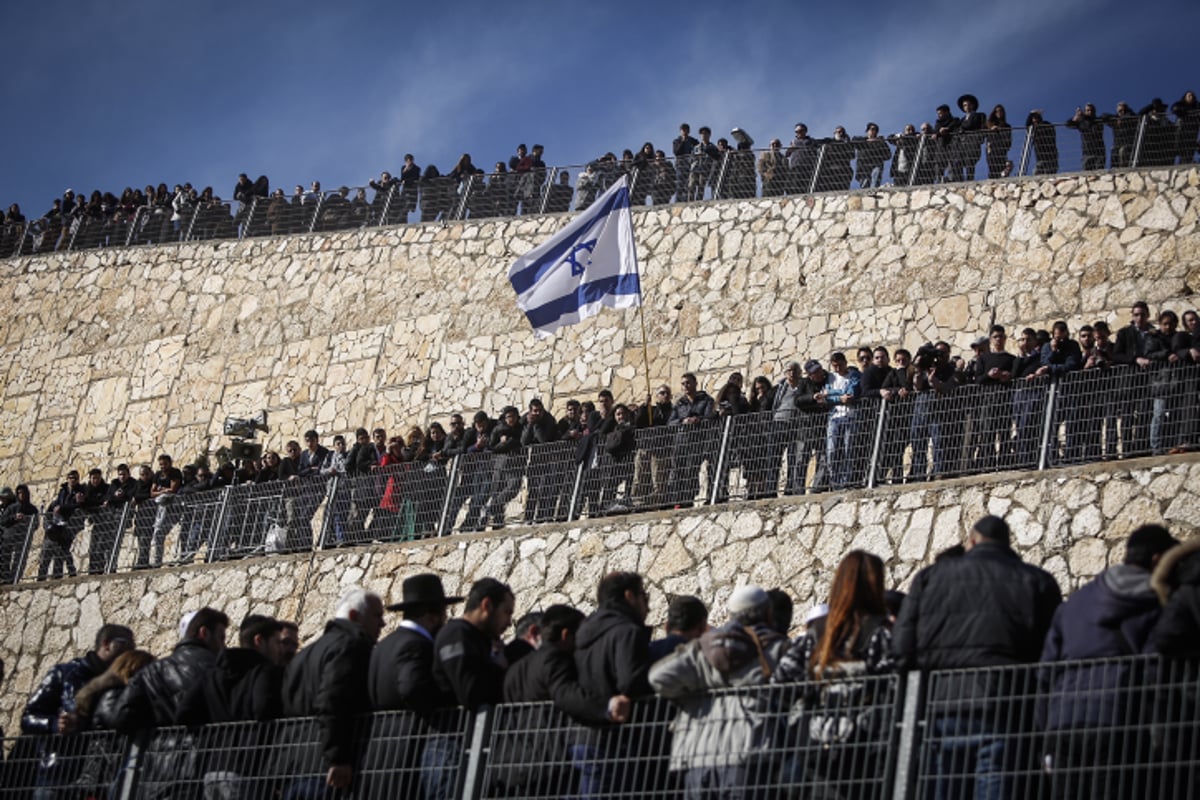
[649,622,787,770]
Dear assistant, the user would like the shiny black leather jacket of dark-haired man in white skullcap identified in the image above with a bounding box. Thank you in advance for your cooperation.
[113,639,217,734]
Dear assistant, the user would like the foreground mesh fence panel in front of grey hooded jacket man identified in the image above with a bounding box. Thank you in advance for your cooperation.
[484,676,898,798]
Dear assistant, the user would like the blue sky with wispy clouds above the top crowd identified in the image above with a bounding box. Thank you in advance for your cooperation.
[0,0,1200,217]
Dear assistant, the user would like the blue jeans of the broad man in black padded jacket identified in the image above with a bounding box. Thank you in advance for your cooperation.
[934,716,1009,800]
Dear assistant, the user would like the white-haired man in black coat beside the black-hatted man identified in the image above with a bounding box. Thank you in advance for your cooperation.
[283,588,383,794]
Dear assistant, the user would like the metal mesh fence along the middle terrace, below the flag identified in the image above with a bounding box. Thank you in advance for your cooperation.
[9,362,1200,582]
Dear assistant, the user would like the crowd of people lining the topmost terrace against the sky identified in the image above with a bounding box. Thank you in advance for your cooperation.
[0,91,1200,257]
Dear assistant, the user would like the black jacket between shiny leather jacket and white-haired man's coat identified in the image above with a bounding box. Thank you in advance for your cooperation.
[175,648,283,724]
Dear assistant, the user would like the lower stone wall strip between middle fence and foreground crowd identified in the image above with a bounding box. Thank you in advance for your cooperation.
[7,455,1200,730]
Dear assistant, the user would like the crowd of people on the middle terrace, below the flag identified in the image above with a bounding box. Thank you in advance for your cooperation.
[0,301,1200,583]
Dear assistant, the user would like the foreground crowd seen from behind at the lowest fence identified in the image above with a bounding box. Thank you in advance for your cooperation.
[8,516,1200,800]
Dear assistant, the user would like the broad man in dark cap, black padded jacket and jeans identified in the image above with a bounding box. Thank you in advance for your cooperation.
[892,516,1062,798]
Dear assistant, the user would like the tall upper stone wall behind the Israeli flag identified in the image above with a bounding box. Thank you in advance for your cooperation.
[0,168,1200,501]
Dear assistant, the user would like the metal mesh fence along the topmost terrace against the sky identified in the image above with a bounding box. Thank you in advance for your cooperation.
[7,114,1200,258]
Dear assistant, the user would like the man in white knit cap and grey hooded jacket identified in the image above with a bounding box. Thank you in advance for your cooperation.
[649,587,787,798]
